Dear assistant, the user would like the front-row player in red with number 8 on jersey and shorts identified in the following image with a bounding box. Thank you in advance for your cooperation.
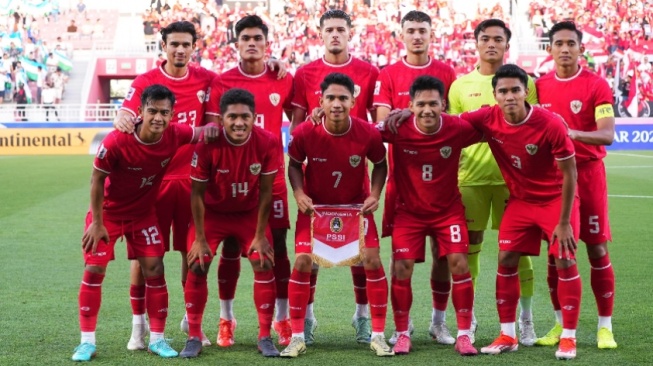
[377,76,483,356]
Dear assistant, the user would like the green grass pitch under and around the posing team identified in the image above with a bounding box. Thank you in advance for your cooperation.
[0,151,653,365]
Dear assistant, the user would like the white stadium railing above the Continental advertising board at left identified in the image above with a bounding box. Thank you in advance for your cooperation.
[0,104,120,123]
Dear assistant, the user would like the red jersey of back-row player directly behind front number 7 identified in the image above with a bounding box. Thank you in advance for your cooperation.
[292,56,379,121]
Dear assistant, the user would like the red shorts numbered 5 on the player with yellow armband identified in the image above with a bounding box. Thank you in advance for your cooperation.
[578,160,612,245]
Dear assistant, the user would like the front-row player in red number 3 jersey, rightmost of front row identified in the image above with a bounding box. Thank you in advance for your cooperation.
[460,65,581,359]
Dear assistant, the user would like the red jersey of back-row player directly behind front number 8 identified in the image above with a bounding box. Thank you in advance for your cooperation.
[374,57,456,109]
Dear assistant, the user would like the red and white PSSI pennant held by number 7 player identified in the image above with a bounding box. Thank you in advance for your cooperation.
[311,205,367,268]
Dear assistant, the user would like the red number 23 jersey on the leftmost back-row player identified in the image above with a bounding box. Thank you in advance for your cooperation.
[120,61,217,180]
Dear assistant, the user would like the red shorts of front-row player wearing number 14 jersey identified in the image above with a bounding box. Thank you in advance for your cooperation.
[187,209,272,261]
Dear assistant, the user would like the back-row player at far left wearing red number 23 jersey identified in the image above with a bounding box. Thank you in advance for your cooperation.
[114,21,216,350]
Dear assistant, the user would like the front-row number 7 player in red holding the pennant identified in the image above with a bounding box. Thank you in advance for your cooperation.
[281,73,394,357]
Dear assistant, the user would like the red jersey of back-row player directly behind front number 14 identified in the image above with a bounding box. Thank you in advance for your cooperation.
[206,65,293,142]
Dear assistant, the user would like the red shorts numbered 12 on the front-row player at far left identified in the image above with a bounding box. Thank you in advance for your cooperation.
[84,212,165,267]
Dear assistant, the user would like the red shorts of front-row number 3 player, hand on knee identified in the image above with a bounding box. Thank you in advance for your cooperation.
[499,197,580,259]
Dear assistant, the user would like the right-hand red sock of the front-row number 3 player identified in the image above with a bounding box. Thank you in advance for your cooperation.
[558,264,583,329]
